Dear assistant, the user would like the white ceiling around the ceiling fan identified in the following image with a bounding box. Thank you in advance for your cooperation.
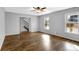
[4,7,70,16]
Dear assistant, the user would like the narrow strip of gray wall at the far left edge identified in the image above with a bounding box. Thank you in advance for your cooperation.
[0,7,5,49]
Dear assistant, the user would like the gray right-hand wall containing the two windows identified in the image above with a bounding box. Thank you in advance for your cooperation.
[39,7,79,41]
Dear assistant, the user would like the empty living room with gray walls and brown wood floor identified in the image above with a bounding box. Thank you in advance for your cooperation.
[0,7,79,51]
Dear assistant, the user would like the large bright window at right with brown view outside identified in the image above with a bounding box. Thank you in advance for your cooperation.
[65,13,79,34]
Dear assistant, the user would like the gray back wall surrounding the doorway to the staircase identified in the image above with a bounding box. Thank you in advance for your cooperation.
[5,12,38,35]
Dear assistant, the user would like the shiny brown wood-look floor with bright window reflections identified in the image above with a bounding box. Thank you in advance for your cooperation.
[1,32,79,51]
